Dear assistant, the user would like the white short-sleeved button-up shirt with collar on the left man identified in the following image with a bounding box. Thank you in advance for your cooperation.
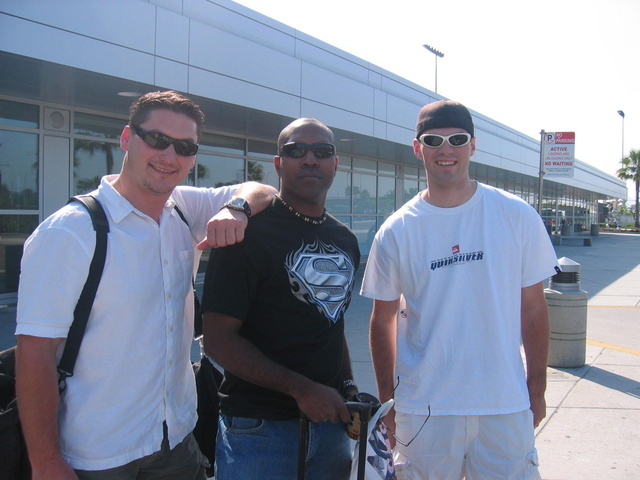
[16,177,237,470]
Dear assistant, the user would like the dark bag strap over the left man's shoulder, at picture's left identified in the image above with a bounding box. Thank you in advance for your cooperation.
[58,195,109,393]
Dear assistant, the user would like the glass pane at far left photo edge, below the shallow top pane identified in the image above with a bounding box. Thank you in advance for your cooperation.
[0,130,38,208]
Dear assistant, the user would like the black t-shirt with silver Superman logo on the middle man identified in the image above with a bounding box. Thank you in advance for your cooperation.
[202,199,360,419]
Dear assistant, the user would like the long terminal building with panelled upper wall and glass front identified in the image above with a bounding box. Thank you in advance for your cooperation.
[0,0,627,299]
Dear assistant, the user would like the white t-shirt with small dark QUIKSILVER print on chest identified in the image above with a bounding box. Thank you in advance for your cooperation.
[360,183,557,415]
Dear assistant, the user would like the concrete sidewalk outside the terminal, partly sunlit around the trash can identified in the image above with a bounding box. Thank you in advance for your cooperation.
[0,233,640,480]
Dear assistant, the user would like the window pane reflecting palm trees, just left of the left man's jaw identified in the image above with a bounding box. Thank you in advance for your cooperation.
[73,139,123,195]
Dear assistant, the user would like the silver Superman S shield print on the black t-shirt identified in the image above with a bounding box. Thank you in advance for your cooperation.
[285,240,354,323]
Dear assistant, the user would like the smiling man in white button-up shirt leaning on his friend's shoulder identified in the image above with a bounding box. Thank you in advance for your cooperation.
[16,92,275,480]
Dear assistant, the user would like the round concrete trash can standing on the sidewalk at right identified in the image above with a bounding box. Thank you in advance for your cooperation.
[544,257,588,368]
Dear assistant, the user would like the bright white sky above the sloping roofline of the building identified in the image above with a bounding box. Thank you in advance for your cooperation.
[235,0,640,198]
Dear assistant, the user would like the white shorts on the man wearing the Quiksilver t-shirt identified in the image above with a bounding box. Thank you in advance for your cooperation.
[395,410,540,480]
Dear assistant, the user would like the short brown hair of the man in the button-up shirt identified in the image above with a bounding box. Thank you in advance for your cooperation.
[129,90,205,136]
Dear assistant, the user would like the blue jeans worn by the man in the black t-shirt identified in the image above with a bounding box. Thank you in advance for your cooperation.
[216,414,353,480]
